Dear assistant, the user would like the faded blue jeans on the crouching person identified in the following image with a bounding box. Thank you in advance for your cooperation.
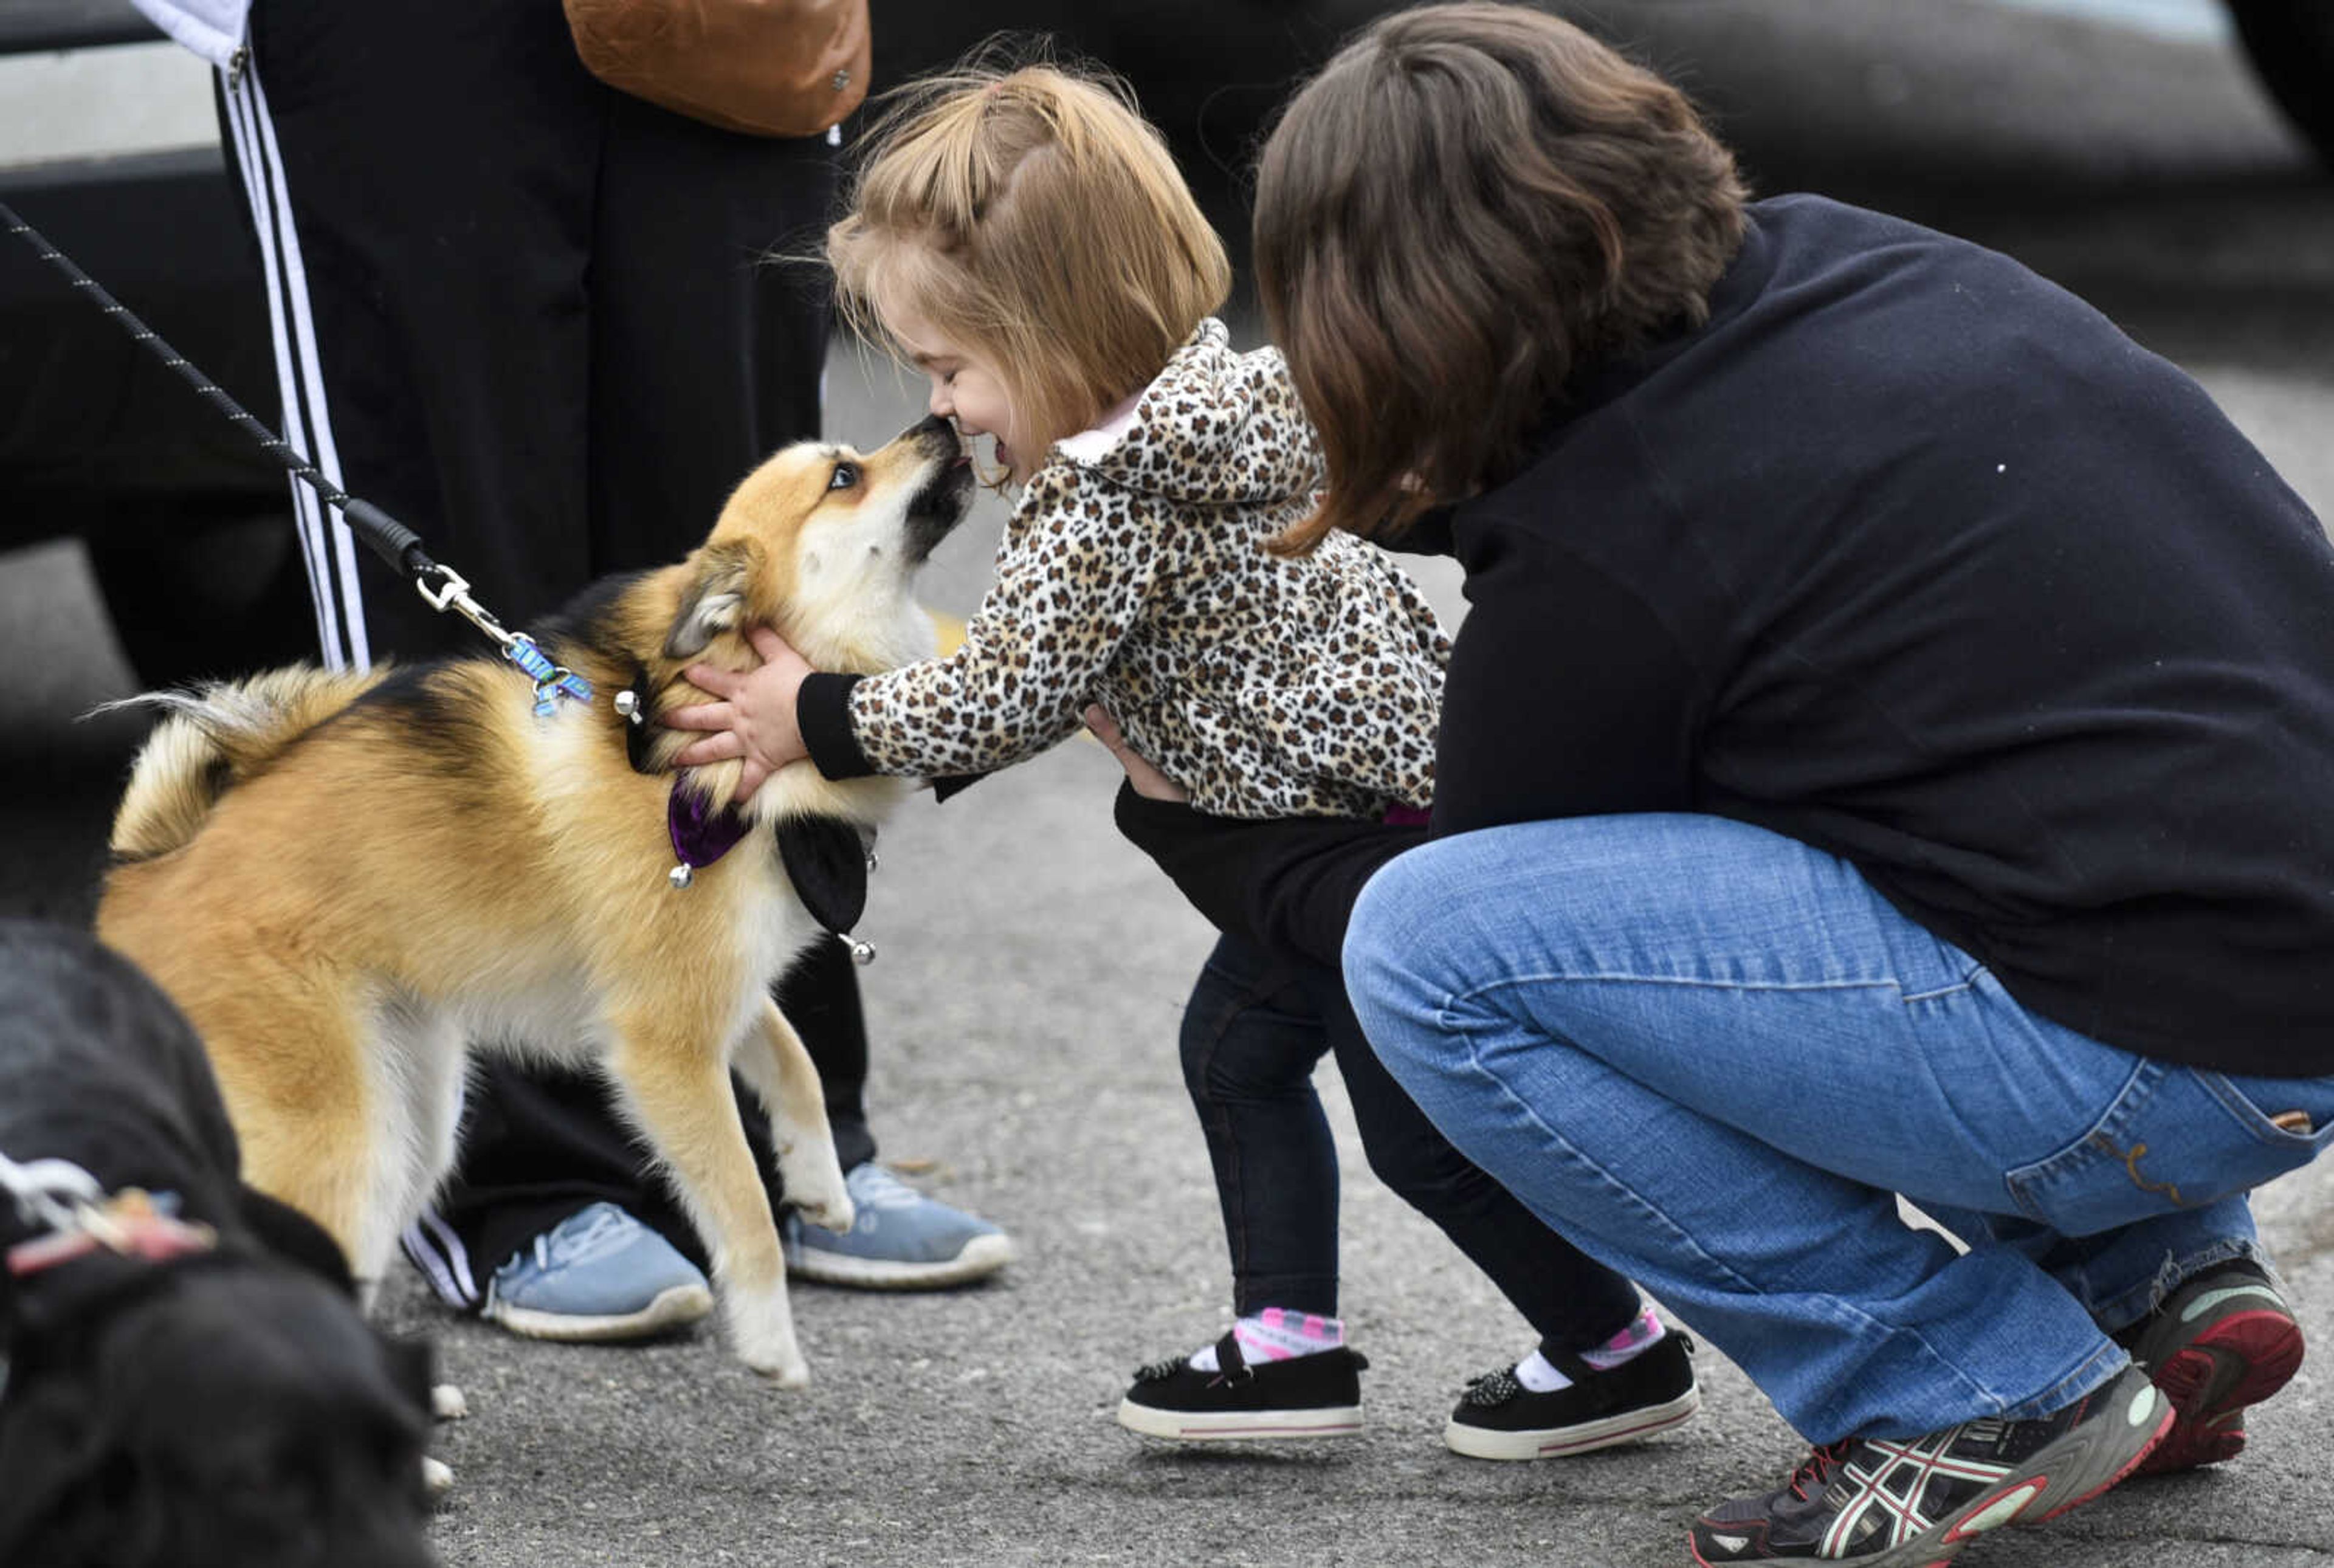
[1344,817,2334,1442]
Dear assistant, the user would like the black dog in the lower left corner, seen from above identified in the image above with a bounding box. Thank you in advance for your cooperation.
[0,922,434,1568]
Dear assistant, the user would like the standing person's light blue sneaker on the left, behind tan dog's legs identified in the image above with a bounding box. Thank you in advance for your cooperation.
[478,1204,714,1342]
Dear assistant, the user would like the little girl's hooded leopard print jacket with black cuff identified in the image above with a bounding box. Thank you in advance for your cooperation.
[850,320,1450,817]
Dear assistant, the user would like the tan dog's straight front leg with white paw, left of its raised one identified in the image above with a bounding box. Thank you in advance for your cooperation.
[609,1017,810,1388]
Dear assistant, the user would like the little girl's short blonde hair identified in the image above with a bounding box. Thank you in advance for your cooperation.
[826,66,1233,445]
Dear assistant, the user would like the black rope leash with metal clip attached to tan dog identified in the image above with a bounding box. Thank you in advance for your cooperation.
[0,201,591,714]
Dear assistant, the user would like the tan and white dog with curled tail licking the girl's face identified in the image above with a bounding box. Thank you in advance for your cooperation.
[98,420,971,1386]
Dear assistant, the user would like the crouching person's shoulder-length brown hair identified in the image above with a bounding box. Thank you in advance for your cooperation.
[1256,5,1746,553]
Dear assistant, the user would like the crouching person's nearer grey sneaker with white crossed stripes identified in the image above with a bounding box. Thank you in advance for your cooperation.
[1687,1367,2173,1568]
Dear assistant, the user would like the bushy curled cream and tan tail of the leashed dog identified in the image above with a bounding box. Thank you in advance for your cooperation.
[95,665,387,861]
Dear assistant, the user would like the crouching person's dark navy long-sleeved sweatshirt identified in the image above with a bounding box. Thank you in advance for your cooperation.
[1120,196,2334,1076]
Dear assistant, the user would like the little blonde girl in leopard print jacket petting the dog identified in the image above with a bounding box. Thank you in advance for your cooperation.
[670,67,1697,1459]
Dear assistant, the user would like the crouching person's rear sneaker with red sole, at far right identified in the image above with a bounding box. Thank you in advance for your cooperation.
[2119,1260,2301,1474]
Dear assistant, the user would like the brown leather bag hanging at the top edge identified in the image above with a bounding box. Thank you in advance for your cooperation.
[565,0,868,136]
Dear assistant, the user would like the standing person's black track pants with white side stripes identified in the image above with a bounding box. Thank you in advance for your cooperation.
[222,0,873,1304]
